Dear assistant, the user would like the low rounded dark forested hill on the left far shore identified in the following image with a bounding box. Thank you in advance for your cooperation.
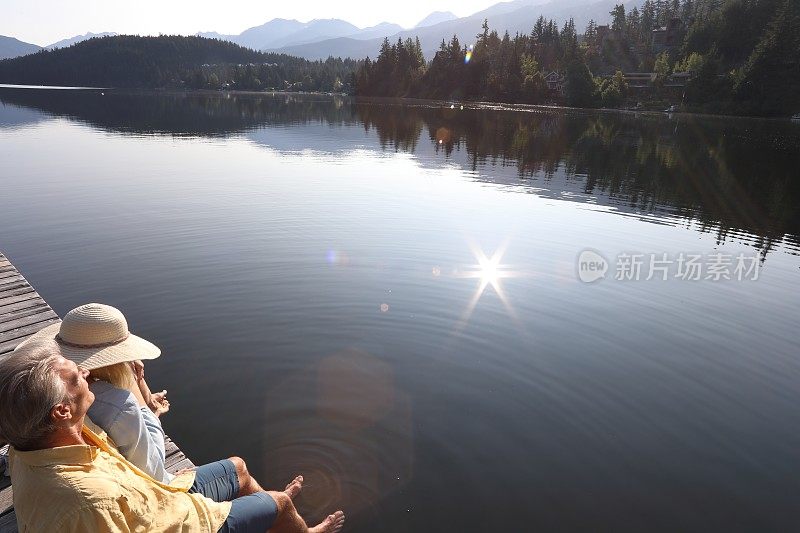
[0,35,357,91]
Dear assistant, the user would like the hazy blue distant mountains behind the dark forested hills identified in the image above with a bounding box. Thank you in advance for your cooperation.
[0,0,643,60]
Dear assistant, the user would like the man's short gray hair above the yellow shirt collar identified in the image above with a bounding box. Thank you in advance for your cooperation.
[0,342,69,450]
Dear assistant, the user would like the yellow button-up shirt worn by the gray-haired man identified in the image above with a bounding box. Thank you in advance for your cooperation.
[9,417,231,533]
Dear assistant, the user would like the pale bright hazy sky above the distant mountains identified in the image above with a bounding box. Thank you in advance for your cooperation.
[0,0,500,46]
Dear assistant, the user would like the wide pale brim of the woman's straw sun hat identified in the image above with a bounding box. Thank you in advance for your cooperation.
[17,323,161,370]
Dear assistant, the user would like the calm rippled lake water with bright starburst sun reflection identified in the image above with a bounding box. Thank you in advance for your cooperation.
[0,89,800,532]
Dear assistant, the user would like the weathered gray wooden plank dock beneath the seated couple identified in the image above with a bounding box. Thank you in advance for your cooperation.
[0,253,194,533]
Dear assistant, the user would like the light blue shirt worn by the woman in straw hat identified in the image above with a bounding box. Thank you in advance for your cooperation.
[88,381,174,483]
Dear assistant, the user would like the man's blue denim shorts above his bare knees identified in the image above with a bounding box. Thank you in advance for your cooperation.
[189,459,278,533]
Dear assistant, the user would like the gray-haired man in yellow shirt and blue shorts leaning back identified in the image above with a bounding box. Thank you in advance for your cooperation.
[0,342,344,533]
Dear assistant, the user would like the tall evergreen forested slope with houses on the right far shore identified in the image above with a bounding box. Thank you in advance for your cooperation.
[354,0,800,115]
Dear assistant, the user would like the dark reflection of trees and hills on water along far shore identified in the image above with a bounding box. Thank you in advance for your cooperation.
[2,89,800,252]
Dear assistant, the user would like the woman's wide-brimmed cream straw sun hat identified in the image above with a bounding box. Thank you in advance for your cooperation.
[17,304,161,370]
